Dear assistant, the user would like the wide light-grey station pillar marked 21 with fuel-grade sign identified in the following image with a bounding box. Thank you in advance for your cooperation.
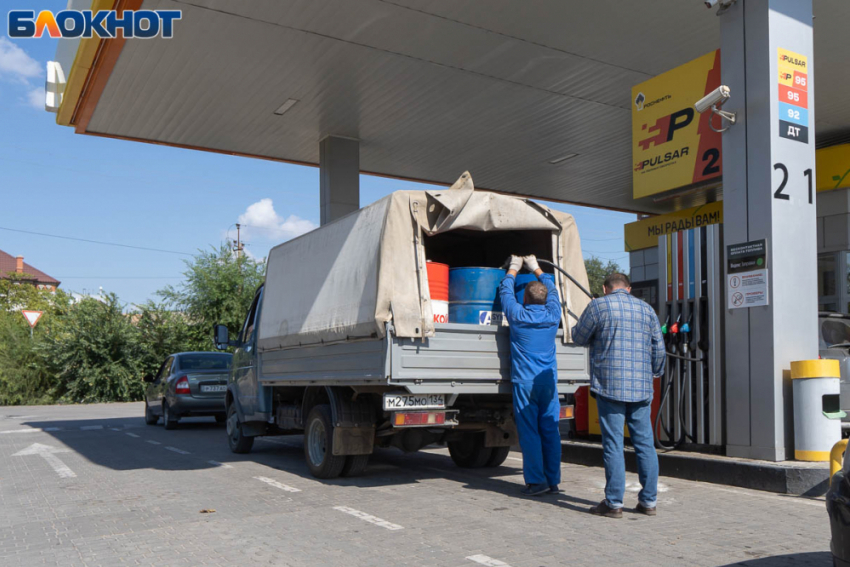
[713,0,818,461]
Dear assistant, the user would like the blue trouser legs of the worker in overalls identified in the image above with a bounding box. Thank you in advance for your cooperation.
[512,376,561,486]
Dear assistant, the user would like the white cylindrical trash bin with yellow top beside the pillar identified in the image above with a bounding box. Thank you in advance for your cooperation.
[791,360,845,462]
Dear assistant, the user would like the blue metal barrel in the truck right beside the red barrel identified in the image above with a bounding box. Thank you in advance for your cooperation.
[449,268,507,325]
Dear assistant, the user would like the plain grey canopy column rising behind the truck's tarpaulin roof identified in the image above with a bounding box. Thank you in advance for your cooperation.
[319,136,360,225]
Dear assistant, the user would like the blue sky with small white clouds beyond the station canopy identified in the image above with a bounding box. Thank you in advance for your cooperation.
[0,7,635,303]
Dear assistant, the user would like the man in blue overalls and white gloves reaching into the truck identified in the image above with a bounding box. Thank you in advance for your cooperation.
[499,256,561,496]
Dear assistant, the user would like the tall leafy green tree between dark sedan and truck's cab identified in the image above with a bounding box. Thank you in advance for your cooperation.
[157,246,265,350]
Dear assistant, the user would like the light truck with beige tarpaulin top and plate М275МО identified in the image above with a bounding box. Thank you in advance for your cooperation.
[215,174,589,478]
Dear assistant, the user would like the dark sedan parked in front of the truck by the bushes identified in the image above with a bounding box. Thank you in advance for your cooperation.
[144,352,233,429]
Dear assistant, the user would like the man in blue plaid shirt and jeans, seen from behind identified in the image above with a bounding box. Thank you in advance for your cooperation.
[572,274,666,518]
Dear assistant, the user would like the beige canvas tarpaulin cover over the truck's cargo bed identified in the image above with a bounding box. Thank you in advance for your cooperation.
[259,172,589,351]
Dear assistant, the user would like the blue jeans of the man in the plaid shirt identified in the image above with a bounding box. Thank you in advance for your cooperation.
[596,396,658,508]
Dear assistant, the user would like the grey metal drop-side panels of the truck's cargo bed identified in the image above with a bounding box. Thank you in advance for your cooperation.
[259,323,589,394]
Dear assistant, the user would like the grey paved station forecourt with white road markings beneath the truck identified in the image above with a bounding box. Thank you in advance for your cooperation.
[0,403,832,567]
